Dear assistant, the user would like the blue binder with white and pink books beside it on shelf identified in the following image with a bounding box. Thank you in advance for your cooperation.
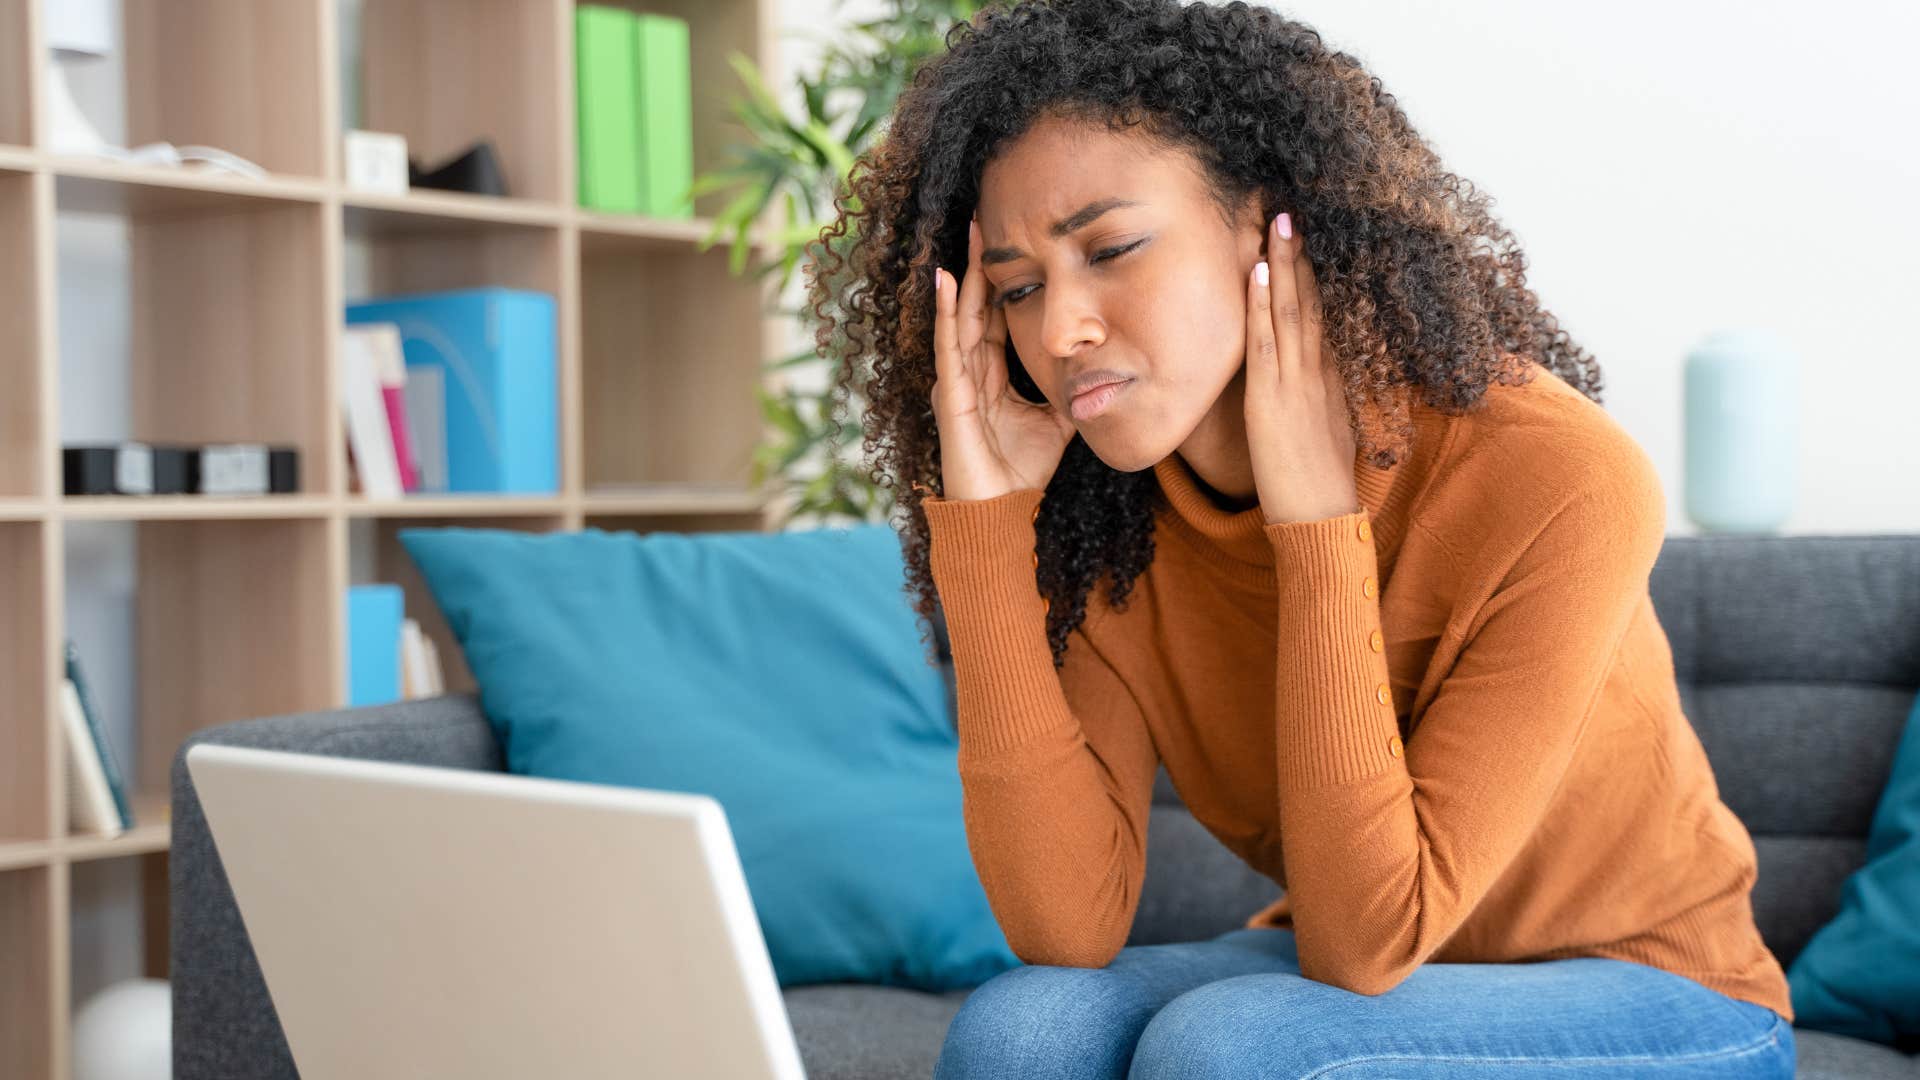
[340,286,561,500]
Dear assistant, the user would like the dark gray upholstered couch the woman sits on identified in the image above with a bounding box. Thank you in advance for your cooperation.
[171,534,1920,1080]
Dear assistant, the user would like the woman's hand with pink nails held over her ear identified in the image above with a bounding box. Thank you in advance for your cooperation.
[1246,213,1361,525]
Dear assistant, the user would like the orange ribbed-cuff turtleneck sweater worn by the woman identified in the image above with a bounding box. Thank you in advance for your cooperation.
[925,365,1793,1020]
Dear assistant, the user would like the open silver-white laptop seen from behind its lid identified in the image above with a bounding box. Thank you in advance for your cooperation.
[186,744,804,1080]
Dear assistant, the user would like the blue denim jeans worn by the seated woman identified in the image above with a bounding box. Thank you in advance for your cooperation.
[933,928,1795,1080]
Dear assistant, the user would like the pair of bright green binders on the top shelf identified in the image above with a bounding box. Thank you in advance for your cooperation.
[574,4,693,217]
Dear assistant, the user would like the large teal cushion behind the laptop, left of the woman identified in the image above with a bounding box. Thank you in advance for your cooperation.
[399,525,1020,992]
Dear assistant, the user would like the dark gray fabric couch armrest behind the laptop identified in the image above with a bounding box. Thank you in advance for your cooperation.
[167,694,505,1080]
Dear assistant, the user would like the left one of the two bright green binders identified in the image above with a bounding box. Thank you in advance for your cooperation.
[574,4,641,213]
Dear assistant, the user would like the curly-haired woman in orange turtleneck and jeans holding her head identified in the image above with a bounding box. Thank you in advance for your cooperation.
[812,0,1795,1080]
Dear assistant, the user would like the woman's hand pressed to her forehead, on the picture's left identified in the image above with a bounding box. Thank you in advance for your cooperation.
[933,219,1073,500]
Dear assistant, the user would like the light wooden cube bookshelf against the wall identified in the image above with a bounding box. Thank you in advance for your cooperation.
[0,0,789,1078]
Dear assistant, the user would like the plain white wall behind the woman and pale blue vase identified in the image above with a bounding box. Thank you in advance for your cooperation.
[785,0,1920,532]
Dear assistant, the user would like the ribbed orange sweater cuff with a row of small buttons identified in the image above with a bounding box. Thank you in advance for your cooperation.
[1265,509,1405,792]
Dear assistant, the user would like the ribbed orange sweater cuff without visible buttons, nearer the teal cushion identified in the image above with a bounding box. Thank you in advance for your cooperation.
[922,488,1079,759]
